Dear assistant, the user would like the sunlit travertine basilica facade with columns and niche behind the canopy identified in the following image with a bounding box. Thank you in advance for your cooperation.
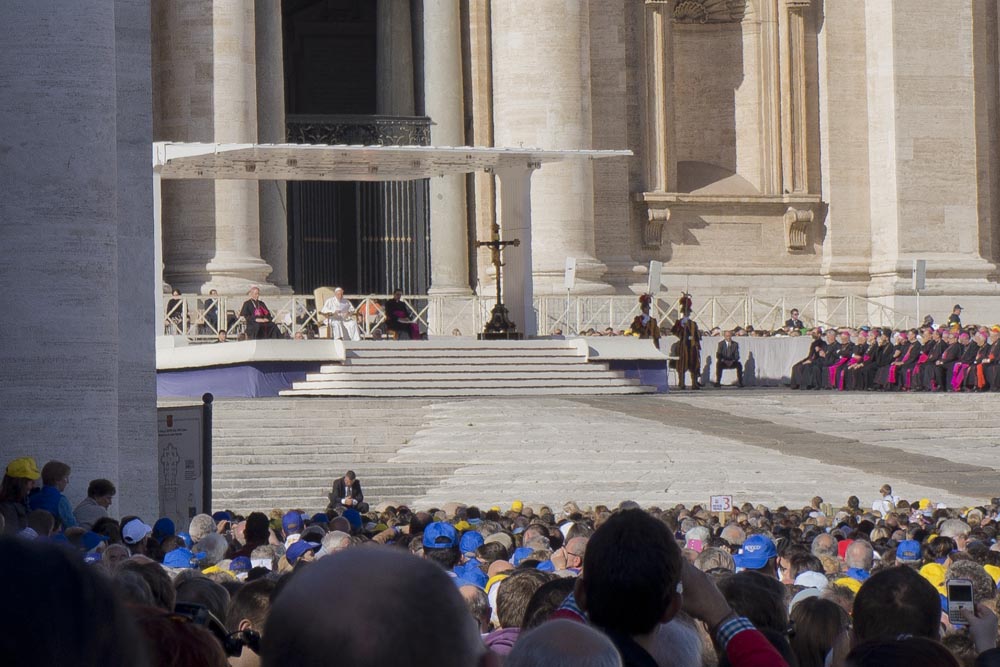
[152,0,1000,318]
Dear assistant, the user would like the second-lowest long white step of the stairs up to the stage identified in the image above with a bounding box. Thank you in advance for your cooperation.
[292,374,640,392]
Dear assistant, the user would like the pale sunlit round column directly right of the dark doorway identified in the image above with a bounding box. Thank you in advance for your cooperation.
[424,0,471,295]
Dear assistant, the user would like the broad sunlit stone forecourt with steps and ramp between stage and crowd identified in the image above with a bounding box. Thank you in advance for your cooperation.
[205,389,1000,510]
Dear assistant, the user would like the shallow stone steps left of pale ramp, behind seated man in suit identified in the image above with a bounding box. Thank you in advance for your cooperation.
[212,399,454,513]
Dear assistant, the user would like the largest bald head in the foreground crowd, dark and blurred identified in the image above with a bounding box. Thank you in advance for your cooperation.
[261,549,485,667]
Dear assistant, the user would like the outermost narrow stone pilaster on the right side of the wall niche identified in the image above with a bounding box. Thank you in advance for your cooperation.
[781,0,812,194]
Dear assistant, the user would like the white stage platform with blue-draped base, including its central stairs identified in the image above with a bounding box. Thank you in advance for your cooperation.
[157,337,668,398]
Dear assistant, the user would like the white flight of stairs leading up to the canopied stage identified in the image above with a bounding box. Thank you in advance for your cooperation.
[281,337,656,397]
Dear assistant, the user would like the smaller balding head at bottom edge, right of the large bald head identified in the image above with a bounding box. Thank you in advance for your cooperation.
[503,619,622,667]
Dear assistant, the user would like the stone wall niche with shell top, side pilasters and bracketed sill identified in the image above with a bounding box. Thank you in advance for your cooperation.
[635,0,823,274]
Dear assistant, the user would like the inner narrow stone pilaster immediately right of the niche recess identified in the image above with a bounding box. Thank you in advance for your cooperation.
[757,0,782,195]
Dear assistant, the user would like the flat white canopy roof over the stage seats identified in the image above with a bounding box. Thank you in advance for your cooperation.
[153,142,632,181]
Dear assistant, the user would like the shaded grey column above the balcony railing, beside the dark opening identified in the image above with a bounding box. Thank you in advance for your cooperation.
[375,0,414,116]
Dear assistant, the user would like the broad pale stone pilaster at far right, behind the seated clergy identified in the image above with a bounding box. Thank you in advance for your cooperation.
[865,0,1000,321]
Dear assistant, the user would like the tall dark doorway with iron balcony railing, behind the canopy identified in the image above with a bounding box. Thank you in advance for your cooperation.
[282,0,430,294]
